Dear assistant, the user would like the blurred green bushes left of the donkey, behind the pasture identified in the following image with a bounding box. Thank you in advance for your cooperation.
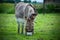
[0,3,14,14]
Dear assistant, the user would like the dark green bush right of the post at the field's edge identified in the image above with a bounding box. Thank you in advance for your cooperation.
[45,4,60,13]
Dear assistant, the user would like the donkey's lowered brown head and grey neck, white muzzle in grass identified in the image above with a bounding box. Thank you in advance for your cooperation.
[26,4,37,35]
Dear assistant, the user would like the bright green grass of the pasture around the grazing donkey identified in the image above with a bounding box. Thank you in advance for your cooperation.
[0,14,60,40]
